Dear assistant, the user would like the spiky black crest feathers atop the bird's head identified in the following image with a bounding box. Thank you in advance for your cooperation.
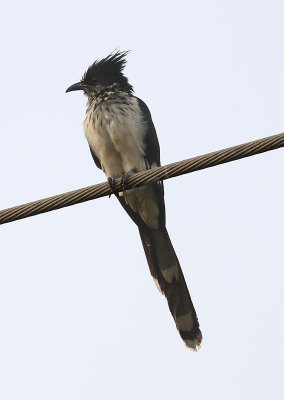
[81,51,133,93]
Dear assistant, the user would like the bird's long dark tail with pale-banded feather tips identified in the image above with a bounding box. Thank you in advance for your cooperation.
[139,228,202,350]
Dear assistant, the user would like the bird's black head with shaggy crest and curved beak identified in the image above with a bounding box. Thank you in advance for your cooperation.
[66,51,133,97]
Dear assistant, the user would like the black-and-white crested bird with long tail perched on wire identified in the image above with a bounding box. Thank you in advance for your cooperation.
[66,50,202,350]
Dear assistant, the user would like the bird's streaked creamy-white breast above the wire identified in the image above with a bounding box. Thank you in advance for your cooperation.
[84,93,146,177]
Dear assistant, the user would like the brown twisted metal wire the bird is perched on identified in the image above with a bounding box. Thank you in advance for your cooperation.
[0,133,284,224]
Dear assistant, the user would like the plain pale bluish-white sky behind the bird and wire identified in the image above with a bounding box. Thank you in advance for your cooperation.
[0,0,284,400]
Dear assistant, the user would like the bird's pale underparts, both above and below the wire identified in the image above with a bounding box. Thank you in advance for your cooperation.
[84,104,159,229]
